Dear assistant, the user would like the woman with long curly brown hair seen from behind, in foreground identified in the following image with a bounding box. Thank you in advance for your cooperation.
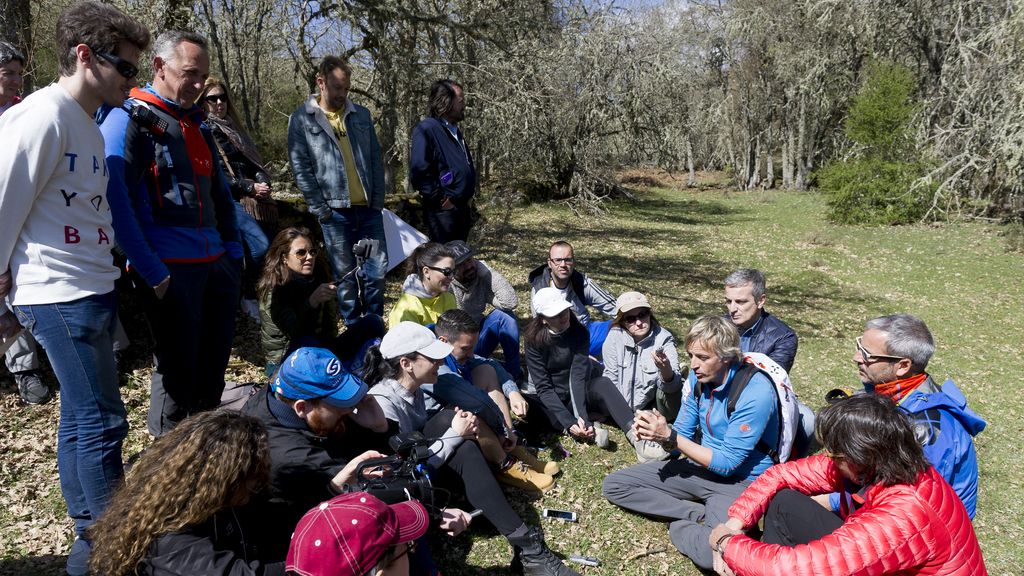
[89,411,284,576]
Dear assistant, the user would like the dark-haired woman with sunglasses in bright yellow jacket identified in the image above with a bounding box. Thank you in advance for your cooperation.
[388,242,458,328]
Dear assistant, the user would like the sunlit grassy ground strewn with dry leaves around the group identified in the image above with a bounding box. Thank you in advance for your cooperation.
[0,170,1024,576]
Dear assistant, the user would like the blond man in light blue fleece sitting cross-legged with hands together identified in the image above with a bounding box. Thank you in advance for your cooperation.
[603,316,779,570]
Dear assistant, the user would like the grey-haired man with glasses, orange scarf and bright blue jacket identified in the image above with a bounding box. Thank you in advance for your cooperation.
[821,314,985,519]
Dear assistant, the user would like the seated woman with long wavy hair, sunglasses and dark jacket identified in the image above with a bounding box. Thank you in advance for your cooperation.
[256,228,384,376]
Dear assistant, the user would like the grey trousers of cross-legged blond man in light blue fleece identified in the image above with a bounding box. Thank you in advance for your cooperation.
[601,460,751,570]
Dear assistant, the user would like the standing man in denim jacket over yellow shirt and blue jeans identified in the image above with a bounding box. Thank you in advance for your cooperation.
[288,56,387,324]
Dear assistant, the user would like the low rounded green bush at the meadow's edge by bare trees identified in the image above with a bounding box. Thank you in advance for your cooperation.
[818,158,935,224]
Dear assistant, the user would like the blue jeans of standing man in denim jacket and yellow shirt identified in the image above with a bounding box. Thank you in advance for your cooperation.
[321,206,387,324]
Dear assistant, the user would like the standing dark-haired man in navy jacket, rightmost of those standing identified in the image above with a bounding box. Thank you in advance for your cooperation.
[409,80,476,243]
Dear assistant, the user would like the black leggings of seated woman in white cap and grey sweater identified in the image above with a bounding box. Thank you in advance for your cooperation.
[423,410,523,536]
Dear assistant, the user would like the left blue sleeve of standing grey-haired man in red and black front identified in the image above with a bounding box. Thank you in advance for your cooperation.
[99,108,171,287]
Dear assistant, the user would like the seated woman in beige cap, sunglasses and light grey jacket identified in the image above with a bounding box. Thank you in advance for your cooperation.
[601,292,683,434]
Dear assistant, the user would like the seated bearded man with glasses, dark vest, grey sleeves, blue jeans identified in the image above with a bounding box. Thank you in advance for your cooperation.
[529,240,615,360]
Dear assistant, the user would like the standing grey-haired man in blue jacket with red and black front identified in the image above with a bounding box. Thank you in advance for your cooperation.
[100,31,243,437]
